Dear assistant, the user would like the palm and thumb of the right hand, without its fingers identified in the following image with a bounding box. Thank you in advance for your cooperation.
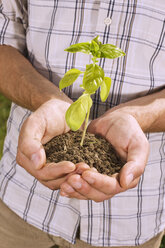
[88,113,149,192]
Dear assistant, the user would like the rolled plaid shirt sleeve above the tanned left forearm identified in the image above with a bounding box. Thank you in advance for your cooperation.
[0,0,27,53]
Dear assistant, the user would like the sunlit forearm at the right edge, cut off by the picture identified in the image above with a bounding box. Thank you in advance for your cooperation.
[109,89,165,132]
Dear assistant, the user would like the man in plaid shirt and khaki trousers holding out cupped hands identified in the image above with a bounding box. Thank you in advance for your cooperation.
[0,0,165,248]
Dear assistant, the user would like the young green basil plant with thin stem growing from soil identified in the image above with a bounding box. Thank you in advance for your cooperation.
[59,36,125,146]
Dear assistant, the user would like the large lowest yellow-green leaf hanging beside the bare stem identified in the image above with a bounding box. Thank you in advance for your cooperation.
[65,94,92,131]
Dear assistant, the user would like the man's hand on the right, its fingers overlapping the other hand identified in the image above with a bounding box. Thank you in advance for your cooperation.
[61,111,149,202]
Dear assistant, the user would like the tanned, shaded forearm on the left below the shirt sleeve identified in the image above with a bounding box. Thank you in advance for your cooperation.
[0,46,71,111]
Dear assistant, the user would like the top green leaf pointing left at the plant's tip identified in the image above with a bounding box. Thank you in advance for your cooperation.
[64,42,91,54]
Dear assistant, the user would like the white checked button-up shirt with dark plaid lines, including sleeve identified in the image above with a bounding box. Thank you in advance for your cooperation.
[0,0,165,246]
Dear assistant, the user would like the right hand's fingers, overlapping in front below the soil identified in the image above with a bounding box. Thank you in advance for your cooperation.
[60,169,124,202]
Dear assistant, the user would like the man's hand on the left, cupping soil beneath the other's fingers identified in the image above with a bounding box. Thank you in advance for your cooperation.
[17,99,78,190]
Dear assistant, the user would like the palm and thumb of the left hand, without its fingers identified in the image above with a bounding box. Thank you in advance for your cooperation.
[18,99,70,169]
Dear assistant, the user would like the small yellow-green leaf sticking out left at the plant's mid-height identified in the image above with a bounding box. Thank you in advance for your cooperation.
[59,68,83,90]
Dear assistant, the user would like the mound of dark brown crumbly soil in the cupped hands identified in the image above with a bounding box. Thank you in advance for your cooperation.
[44,131,124,175]
